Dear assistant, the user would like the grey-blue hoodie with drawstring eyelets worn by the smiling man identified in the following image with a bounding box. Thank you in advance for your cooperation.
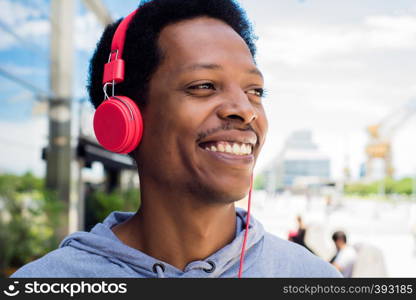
[11,209,341,278]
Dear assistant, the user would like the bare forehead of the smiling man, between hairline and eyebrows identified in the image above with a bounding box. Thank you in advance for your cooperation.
[155,17,263,78]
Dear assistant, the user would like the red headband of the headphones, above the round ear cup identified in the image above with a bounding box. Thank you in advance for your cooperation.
[103,9,138,86]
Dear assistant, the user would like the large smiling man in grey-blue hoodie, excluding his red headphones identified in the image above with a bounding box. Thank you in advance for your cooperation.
[14,0,339,278]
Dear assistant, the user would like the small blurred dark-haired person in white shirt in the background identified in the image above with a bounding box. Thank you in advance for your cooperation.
[331,231,357,277]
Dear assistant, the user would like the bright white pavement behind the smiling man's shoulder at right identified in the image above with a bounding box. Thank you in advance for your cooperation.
[252,192,416,277]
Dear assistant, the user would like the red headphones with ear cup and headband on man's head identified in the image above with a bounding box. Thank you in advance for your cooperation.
[94,10,143,154]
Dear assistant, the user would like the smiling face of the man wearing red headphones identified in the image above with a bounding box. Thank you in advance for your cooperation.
[137,17,267,203]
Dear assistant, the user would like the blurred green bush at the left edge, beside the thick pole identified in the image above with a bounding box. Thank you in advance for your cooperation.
[0,173,62,276]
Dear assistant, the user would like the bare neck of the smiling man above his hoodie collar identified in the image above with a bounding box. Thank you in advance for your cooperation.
[112,180,236,270]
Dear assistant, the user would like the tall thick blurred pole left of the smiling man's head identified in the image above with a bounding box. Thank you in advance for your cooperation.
[46,0,75,237]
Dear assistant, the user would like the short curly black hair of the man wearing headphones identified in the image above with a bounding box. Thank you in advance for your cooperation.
[87,0,256,108]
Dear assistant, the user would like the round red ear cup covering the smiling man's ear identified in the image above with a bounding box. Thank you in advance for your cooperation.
[94,96,143,154]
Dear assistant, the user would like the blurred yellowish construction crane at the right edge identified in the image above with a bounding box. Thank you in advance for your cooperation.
[365,98,416,179]
